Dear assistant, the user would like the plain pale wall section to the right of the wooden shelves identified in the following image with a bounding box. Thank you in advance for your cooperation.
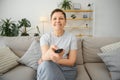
[94,0,120,37]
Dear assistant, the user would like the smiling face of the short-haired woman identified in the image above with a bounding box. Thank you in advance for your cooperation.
[51,12,66,30]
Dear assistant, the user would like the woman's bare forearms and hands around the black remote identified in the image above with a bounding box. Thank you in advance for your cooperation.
[38,45,77,66]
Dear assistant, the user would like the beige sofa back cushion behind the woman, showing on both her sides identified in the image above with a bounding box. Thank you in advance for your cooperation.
[0,36,83,64]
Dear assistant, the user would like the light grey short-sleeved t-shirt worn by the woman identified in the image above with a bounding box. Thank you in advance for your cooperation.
[40,31,77,58]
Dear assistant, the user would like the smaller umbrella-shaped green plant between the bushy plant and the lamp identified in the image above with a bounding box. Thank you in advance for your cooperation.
[18,18,31,36]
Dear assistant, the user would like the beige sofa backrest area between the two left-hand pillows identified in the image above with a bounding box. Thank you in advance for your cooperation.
[0,36,33,57]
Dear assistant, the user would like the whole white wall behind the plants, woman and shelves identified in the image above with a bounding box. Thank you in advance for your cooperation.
[0,0,120,37]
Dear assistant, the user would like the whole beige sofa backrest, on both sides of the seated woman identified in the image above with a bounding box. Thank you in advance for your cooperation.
[0,36,120,64]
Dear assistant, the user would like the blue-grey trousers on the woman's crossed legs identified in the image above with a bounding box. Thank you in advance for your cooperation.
[37,61,77,80]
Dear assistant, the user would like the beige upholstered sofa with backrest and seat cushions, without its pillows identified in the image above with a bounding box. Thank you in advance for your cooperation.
[0,36,120,80]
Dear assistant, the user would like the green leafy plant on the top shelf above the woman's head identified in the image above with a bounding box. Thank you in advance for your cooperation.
[59,0,72,10]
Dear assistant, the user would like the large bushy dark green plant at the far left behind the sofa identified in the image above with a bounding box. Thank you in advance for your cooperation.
[0,19,19,36]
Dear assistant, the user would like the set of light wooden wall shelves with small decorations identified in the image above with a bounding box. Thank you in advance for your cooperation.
[64,10,93,37]
